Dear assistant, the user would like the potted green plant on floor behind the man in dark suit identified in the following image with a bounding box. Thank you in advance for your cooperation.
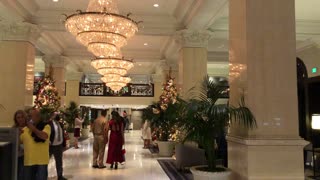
[63,101,80,144]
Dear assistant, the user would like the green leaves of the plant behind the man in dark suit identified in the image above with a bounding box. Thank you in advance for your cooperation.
[63,101,80,132]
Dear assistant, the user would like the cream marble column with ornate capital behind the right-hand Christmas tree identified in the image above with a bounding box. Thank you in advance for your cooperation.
[175,30,212,98]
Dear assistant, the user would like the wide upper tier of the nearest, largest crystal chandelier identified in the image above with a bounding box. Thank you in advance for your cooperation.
[65,0,138,53]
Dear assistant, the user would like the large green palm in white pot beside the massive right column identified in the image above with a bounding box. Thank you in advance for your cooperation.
[181,77,257,180]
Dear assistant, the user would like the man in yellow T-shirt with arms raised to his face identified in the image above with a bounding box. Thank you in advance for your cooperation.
[20,110,51,180]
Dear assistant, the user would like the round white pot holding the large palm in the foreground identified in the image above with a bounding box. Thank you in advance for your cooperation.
[190,166,231,180]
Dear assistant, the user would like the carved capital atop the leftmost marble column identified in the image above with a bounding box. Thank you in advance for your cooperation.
[0,21,41,45]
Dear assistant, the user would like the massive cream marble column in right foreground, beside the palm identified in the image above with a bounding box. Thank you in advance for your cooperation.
[227,0,306,180]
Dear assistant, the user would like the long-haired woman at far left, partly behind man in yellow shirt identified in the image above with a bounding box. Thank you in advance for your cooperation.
[13,110,27,180]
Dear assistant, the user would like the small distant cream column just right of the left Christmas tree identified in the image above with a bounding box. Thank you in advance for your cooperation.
[65,72,83,107]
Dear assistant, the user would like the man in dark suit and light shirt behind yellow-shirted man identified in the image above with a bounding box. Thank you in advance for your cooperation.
[49,114,66,180]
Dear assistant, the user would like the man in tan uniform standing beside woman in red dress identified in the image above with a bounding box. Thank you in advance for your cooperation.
[92,110,108,169]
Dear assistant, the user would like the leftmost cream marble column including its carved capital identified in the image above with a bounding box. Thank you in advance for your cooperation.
[0,22,40,126]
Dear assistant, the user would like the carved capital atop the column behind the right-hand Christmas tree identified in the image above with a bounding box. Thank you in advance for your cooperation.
[174,29,213,48]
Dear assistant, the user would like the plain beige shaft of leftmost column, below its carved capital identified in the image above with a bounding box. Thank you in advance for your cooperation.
[0,41,35,126]
